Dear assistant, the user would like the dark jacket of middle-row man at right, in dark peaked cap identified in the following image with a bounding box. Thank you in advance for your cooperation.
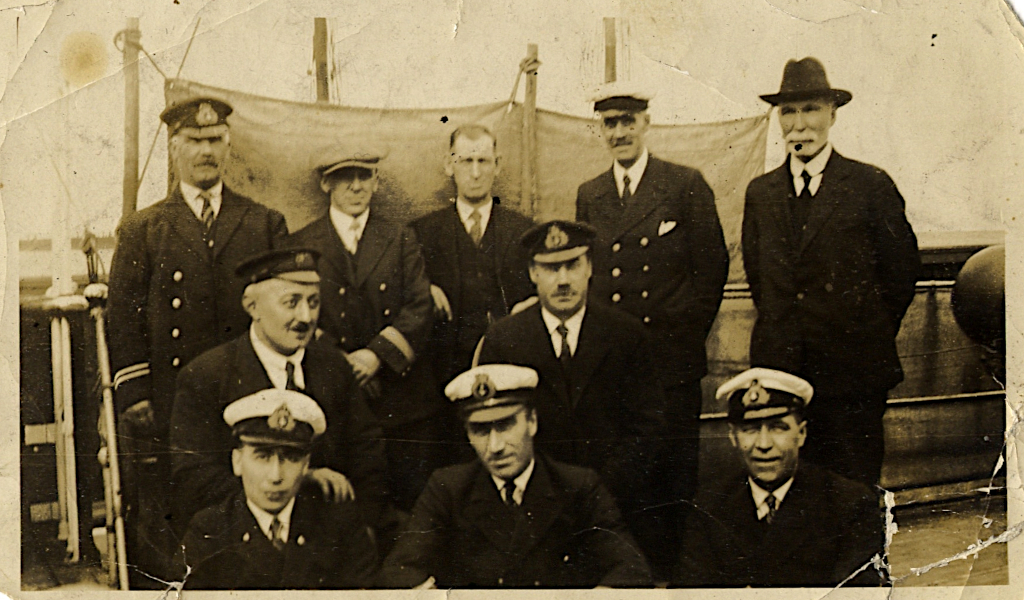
[480,303,666,513]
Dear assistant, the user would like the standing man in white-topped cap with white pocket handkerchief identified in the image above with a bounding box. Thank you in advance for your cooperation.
[577,82,729,570]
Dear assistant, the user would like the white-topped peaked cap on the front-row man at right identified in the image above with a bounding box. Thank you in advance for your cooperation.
[715,367,814,423]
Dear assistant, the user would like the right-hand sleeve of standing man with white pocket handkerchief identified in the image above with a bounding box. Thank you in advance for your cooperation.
[665,172,729,337]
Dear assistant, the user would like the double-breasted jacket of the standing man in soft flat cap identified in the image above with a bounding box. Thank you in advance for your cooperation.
[289,209,444,428]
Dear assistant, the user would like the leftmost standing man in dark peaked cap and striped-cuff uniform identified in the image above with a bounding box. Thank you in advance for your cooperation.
[106,98,288,586]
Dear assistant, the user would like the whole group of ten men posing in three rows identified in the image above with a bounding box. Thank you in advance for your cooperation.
[109,58,919,589]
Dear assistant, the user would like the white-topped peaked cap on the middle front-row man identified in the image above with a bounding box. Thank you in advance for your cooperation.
[444,365,538,422]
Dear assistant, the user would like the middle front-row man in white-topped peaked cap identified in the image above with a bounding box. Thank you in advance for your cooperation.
[381,365,650,589]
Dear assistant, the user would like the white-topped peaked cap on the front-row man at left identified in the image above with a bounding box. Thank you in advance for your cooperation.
[223,388,327,447]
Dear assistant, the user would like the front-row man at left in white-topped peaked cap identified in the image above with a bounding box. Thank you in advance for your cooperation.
[183,389,377,590]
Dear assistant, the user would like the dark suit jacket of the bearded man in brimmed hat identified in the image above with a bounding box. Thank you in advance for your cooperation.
[742,151,920,395]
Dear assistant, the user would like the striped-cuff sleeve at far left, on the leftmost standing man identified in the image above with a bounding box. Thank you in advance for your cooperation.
[106,217,153,414]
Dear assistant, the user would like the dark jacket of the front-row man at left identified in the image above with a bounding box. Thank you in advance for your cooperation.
[182,486,378,590]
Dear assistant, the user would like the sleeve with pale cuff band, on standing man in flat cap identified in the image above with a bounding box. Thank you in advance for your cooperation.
[367,226,433,373]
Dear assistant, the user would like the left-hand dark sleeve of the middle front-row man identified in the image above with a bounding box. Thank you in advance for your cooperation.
[379,473,453,589]
